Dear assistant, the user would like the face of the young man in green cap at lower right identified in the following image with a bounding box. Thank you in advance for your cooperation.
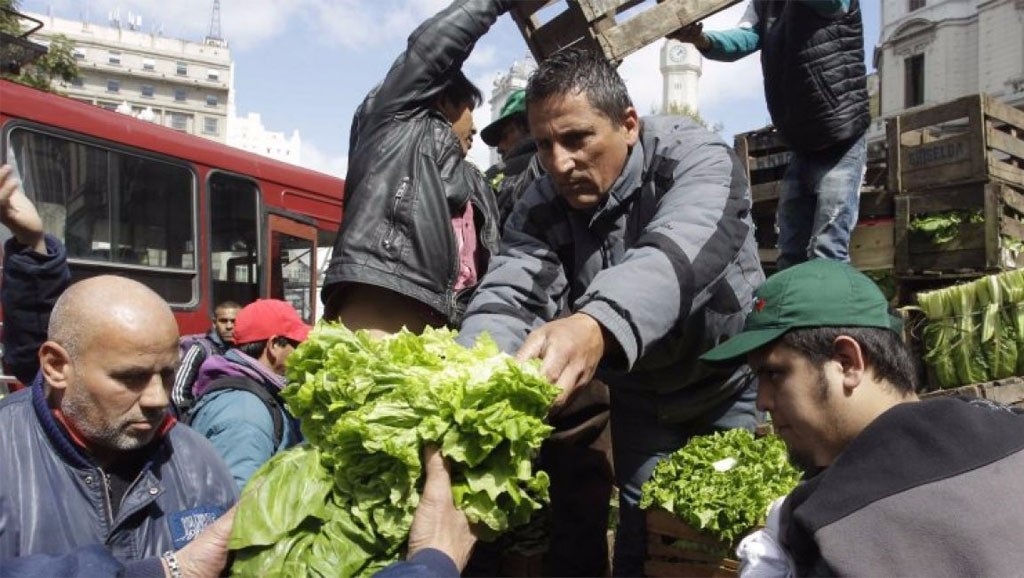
[748,342,848,468]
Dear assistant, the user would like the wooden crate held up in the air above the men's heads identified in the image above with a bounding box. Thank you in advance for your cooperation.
[511,0,739,64]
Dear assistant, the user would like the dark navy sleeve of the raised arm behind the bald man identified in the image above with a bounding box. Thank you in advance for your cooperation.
[0,235,71,383]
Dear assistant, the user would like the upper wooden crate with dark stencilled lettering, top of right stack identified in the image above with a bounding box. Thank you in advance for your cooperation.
[886,94,1024,193]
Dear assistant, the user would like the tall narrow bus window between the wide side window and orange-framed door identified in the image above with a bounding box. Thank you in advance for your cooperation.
[208,172,261,307]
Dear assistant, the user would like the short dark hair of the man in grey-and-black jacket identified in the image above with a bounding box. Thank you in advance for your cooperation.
[526,48,633,122]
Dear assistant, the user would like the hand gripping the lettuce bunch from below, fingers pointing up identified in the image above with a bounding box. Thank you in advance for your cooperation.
[409,447,476,572]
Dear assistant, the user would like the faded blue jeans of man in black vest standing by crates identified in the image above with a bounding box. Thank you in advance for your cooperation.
[777,136,867,271]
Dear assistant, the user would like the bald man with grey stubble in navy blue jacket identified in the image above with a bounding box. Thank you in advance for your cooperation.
[0,276,238,578]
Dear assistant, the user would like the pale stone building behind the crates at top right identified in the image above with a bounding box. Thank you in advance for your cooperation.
[871,0,1024,134]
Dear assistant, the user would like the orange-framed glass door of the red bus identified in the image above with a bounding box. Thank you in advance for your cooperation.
[268,215,316,323]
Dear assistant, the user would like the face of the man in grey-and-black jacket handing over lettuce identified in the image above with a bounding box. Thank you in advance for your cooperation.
[529,93,640,209]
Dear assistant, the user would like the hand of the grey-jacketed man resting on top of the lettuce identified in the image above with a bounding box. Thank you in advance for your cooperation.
[516,314,605,412]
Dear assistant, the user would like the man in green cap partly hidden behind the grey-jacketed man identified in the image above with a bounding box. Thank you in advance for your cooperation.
[480,89,544,226]
